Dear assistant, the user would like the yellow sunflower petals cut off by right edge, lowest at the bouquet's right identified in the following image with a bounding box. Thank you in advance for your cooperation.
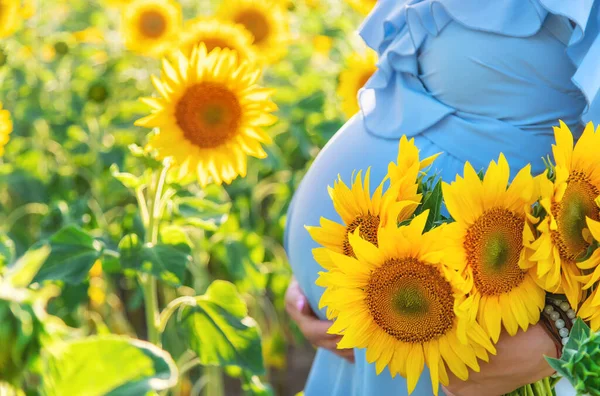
[577,196,600,332]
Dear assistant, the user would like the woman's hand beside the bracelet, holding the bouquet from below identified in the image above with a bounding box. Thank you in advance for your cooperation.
[444,324,557,396]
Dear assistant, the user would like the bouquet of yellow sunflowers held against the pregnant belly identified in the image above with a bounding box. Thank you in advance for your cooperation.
[307,122,600,395]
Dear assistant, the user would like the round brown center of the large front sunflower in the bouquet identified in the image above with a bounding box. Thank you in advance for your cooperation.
[366,258,454,343]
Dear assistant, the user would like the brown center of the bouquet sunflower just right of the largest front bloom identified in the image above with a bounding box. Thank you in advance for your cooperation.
[464,208,525,296]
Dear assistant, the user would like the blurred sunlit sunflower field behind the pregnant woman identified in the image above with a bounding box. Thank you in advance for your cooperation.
[0,0,375,396]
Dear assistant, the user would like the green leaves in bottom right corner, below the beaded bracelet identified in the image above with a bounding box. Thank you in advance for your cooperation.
[546,318,600,396]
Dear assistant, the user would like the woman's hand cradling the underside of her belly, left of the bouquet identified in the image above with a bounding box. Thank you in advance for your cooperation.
[285,278,354,363]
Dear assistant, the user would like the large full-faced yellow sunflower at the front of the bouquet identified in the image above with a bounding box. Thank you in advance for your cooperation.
[319,211,495,394]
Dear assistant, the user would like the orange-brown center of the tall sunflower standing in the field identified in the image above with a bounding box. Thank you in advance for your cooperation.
[175,82,242,148]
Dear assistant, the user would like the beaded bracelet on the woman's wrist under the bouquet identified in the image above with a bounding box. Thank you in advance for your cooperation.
[541,296,577,366]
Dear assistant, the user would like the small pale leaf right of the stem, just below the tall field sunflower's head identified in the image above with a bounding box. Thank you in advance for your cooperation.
[173,197,231,231]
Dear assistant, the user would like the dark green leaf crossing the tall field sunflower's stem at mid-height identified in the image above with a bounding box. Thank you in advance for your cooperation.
[119,234,191,286]
